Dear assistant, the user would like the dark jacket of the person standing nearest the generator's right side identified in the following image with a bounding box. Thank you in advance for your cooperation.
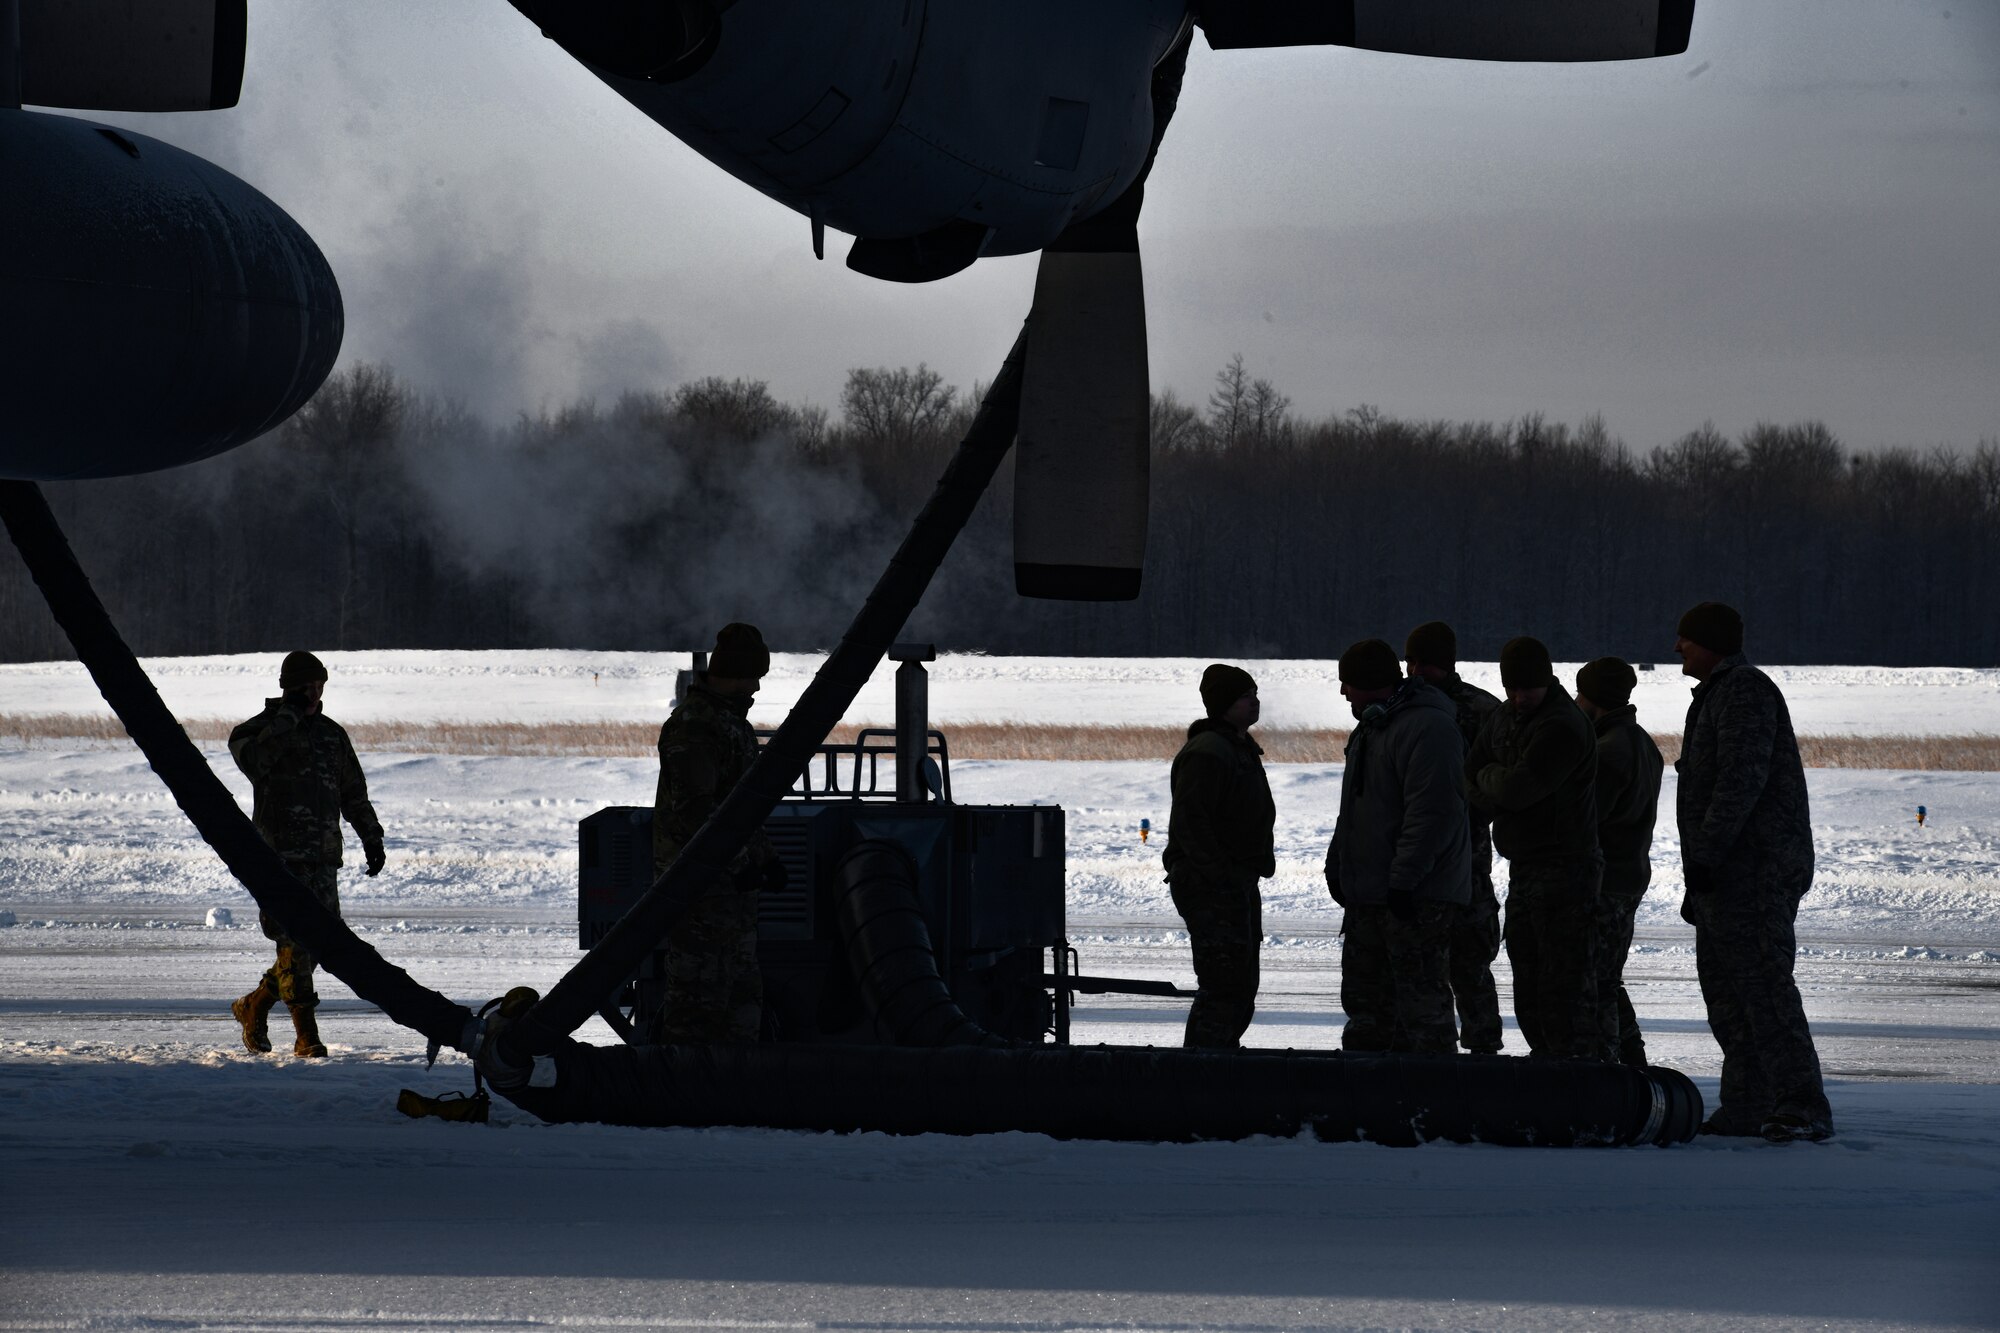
[1160,717,1278,883]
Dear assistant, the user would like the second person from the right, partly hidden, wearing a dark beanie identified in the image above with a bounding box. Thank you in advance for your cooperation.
[1576,656,1666,1067]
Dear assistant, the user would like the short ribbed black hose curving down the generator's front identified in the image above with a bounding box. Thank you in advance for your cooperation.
[834,839,1008,1047]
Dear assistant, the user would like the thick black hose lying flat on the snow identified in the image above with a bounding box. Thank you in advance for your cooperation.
[498,1041,1702,1147]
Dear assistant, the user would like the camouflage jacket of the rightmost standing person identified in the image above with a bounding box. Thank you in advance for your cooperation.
[1674,652,1812,875]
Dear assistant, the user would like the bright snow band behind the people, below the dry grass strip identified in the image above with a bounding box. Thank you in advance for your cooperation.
[0,745,2000,944]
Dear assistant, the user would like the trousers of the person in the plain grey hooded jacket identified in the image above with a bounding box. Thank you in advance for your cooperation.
[1340,903,1462,1055]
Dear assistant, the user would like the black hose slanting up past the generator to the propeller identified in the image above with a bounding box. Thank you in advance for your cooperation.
[512,324,1026,1069]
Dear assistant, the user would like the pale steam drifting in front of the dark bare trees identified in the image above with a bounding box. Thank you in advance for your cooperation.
[404,394,882,646]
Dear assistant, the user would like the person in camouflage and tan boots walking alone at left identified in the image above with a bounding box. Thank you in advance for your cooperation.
[230,652,386,1057]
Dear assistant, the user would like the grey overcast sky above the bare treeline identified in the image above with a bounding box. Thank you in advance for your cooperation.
[86,0,2000,448]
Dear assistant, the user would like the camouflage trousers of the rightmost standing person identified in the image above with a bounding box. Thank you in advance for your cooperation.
[1680,856,1832,1133]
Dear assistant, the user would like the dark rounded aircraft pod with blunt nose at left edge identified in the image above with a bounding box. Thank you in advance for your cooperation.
[0,110,342,480]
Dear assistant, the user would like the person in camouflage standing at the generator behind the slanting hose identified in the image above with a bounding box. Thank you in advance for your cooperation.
[648,624,784,1045]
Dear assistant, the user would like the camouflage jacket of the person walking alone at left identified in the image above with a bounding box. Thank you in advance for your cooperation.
[230,699,382,865]
